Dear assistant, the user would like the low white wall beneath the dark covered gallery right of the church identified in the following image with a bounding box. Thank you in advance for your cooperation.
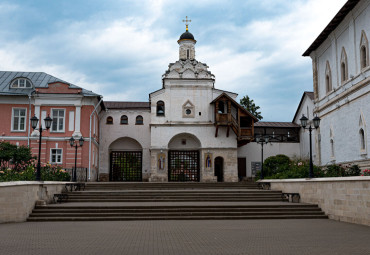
[238,142,300,177]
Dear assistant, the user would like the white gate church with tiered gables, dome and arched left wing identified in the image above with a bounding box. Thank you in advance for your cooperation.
[99,25,258,182]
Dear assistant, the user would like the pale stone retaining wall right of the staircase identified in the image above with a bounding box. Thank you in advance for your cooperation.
[262,176,370,226]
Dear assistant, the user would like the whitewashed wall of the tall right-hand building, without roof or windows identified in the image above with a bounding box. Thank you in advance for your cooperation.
[311,0,370,168]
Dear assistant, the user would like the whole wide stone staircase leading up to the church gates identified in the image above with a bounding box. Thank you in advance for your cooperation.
[28,183,327,221]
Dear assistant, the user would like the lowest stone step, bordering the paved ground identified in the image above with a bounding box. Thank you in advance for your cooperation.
[27,214,328,221]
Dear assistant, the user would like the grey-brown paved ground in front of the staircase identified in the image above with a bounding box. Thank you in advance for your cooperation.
[0,220,370,255]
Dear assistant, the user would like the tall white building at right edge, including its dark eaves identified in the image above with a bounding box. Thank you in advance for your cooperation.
[303,0,370,169]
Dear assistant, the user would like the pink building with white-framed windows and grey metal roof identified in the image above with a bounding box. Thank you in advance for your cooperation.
[0,72,104,180]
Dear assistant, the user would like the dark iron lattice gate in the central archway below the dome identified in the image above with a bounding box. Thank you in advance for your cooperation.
[168,151,200,182]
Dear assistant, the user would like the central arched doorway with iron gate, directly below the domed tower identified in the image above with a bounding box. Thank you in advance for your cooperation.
[168,133,201,182]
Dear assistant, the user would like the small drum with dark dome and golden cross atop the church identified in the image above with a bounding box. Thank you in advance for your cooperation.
[177,16,197,60]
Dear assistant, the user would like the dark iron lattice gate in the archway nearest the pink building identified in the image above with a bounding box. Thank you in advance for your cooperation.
[109,151,142,182]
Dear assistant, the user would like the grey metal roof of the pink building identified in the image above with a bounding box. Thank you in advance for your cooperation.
[0,71,100,96]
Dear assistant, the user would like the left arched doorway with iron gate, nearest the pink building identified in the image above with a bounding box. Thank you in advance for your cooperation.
[109,137,143,182]
